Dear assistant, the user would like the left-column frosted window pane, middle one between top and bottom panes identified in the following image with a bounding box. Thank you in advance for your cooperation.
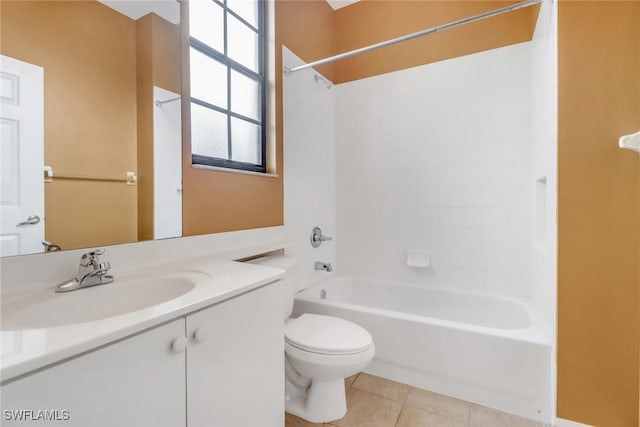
[191,48,227,109]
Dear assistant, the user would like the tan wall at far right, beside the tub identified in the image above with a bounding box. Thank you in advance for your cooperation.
[558,1,640,427]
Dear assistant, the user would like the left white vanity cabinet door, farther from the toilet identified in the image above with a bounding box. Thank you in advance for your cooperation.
[1,319,186,427]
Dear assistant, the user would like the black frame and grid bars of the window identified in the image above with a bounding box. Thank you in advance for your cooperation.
[188,0,267,174]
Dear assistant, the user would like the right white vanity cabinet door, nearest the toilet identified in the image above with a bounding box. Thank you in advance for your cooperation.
[187,281,284,427]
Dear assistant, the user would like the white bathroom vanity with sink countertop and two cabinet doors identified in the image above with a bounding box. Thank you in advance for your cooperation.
[1,259,284,427]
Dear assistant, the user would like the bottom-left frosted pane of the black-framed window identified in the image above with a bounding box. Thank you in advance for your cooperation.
[191,103,229,159]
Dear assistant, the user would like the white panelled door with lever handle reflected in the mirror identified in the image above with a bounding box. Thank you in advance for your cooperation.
[0,56,44,256]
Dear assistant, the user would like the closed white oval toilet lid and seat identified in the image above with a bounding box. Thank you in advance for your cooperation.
[284,313,373,354]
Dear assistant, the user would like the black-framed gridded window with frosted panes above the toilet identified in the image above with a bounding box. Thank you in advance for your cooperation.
[189,0,266,172]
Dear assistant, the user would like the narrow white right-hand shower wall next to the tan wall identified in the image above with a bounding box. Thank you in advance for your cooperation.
[530,0,560,425]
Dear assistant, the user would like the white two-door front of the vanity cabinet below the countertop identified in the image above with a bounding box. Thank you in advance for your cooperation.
[1,282,284,427]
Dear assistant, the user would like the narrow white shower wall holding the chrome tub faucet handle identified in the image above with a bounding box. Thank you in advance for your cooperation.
[283,48,340,289]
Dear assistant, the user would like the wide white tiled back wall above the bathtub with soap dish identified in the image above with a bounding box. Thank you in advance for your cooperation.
[335,43,533,295]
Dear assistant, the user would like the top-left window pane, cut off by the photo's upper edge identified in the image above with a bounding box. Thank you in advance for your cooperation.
[189,0,224,53]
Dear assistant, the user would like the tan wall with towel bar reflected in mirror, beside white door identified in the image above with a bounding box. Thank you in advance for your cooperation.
[0,1,136,249]
